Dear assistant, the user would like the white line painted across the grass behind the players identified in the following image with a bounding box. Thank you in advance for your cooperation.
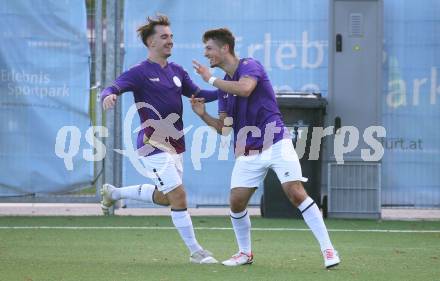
[0,226,440,233]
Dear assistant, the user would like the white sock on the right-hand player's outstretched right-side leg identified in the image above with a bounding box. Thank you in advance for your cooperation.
[298,197,333,251]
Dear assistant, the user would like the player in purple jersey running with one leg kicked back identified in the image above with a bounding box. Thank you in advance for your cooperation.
[101,15,217,264]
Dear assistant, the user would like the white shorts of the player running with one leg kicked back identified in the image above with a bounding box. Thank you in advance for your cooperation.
[141,152,183,194]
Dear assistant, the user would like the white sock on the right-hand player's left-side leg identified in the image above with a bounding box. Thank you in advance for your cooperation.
[231,210,252,254]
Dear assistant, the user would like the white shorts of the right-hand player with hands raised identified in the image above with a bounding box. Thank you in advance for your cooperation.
[231,139,307,188]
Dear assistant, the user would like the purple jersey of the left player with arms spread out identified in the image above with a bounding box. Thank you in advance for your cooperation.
[101,60,217,156]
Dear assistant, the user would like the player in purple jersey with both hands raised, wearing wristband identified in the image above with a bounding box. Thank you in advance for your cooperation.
[191,28,340,268]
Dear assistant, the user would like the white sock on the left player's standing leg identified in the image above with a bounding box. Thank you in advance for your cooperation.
[171,209,202,254]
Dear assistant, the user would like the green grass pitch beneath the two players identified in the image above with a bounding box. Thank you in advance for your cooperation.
[0,216,440,281]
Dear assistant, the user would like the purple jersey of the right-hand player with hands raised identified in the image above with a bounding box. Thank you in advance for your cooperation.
[218,58,287,157]
